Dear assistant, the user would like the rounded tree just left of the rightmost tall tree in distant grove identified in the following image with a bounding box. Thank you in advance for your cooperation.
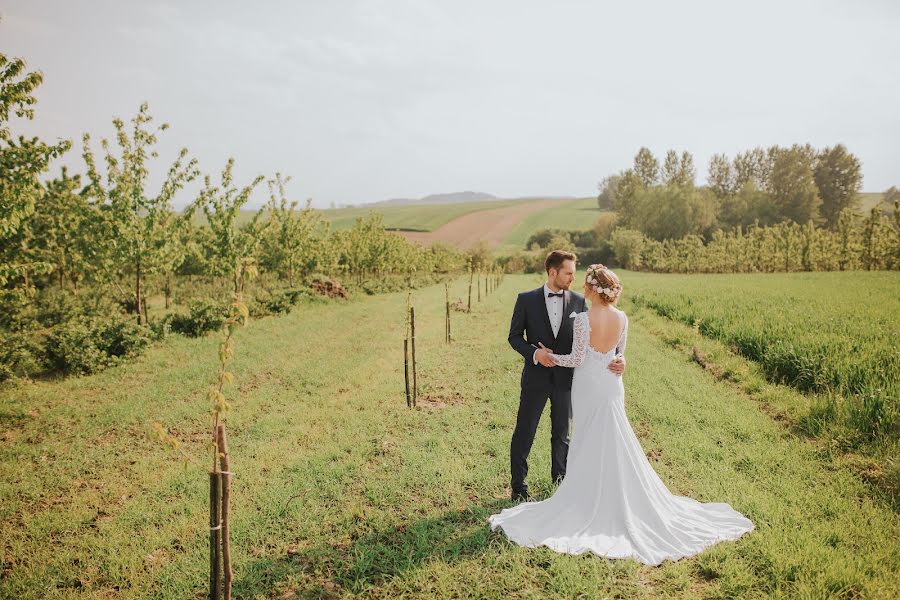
[770,144,822,224]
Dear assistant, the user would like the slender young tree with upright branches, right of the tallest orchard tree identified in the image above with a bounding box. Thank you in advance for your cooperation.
[196,158,264,293]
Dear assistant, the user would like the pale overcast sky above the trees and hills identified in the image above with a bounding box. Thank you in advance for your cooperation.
[0,0,900,207]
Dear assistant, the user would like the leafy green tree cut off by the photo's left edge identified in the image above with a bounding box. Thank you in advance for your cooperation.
[0,53,71,289]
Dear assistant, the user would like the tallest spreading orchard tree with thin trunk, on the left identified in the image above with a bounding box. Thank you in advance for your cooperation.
[83,102,199,323]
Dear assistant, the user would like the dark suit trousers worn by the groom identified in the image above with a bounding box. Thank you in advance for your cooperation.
[509,388,572,493]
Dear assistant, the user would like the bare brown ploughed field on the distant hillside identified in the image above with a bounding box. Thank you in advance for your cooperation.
[396,200,563,248]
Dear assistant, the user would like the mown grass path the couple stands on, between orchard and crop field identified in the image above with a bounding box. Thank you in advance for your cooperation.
[0,276,900,599]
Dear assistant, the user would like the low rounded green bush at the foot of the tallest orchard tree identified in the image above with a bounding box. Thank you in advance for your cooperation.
[46,315,150,374]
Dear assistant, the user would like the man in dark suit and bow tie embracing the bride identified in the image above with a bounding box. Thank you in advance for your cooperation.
[509,250,625,500]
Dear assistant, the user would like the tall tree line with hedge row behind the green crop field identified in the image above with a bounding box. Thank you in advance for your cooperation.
[588,144,900,272]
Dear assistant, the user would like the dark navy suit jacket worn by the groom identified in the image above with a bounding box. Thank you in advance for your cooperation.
[509,285,587,393]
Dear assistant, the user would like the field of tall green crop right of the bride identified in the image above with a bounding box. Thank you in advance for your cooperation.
[629,272,900,440]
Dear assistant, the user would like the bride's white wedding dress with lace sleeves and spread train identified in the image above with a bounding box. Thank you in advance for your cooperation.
[489,312,753,565]
